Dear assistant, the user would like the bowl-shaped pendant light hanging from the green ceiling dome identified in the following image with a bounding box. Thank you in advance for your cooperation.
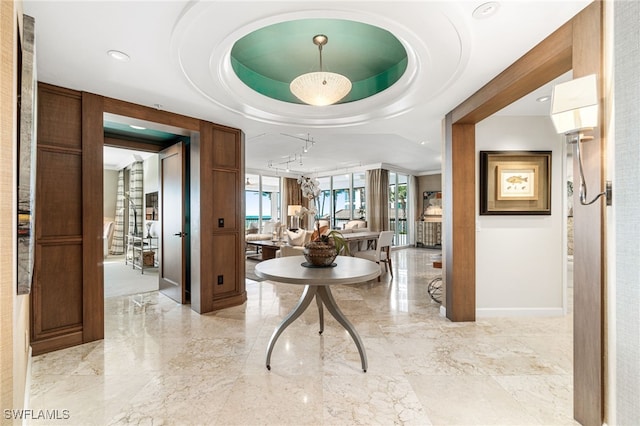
[289,34,351,106]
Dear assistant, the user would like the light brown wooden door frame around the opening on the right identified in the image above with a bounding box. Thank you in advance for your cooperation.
[443,1,607,425]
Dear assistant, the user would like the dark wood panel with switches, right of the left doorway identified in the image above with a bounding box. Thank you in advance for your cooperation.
[190,122,247,313]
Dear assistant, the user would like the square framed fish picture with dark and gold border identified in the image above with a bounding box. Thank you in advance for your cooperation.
[480,151,551,215]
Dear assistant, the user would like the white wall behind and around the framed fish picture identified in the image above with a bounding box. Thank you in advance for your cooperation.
[476,116,566,317]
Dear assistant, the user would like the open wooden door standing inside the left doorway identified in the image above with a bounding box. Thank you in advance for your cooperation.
[158,142,188,303]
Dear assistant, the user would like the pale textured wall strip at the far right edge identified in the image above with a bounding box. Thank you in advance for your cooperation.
[605,1,640,425]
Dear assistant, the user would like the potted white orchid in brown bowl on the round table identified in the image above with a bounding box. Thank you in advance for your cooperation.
[298,176,349,266]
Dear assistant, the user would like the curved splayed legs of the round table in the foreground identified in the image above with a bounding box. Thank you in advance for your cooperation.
[266,285,367,373]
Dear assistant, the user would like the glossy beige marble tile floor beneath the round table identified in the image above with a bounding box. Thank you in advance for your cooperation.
[30,248,577,425]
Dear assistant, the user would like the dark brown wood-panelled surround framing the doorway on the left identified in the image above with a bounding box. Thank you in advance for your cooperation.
[30,82,247,355]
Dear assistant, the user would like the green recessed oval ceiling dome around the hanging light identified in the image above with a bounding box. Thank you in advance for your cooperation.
[231,19,407,103]
